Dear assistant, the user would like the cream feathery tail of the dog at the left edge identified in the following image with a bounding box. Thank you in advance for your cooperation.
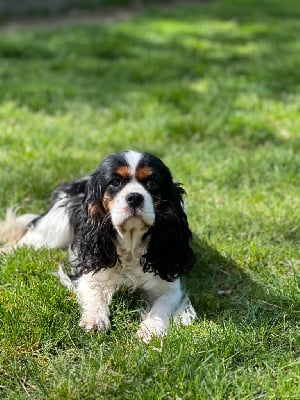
[0,208,38,253]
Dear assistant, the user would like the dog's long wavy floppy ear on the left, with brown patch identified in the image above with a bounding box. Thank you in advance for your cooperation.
[72,174,117,273]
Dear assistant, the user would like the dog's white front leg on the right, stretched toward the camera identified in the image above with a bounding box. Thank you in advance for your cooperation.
[137,277,183,343]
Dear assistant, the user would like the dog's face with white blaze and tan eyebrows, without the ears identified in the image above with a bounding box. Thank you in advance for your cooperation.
[89,151,171,234]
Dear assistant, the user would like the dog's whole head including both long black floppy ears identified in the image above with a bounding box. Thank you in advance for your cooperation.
[75,151,193,280]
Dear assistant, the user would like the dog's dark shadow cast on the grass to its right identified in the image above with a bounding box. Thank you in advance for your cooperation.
[185,237,300,328]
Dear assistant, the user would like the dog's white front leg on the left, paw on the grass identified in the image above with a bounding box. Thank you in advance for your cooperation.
[76,273,114,331]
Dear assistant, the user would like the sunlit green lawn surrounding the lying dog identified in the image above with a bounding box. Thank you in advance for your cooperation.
[0,0,300,400]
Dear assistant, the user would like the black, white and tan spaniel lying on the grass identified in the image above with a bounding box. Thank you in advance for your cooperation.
[0,150,196,343]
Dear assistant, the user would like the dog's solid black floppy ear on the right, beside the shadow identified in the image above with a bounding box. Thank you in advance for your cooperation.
[141,182,195,281]
